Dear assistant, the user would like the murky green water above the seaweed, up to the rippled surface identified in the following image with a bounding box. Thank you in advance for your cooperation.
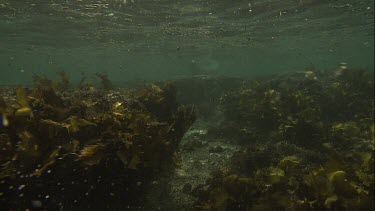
[0,0,374,85]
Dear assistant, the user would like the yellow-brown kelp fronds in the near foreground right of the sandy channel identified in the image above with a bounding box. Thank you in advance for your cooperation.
[195,148,374,210]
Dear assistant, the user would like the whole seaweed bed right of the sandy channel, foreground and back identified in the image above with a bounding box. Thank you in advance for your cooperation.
[192,69,375,210]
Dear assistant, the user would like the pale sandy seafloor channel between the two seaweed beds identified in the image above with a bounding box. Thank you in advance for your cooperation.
[146,119,240,210]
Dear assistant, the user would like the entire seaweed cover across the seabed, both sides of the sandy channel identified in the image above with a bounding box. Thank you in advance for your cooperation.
[0,69,375,211]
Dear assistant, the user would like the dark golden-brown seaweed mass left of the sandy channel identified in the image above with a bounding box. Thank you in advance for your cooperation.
[0,72,195,210]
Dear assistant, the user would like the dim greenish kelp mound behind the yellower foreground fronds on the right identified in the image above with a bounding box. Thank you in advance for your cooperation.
[221,70,374,148]
